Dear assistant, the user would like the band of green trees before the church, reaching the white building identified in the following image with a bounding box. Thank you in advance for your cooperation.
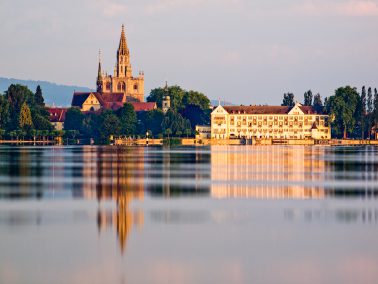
[64,86,211,144]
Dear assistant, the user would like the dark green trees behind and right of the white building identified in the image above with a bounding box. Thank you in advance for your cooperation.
[281,86,378,139]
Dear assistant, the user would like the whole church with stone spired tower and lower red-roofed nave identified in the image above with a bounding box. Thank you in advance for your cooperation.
[71,25,148,112]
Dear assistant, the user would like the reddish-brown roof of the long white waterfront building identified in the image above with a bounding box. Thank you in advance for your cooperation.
[223,105,316,114]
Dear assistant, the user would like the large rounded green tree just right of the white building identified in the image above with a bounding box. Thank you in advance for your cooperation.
[326,86,361,138]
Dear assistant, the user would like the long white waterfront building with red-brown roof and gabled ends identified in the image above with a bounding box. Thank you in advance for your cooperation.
[211,103,331,139]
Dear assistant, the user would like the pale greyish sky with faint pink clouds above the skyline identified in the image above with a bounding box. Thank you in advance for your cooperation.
[0,0,378,105]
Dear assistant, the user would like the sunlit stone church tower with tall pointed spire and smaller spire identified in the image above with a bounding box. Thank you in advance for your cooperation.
[96,25,144,102]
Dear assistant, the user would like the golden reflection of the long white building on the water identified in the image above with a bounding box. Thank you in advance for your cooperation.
[211,146,325,199]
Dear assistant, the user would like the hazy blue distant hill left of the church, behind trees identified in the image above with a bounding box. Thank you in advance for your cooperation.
[0,77,92,106]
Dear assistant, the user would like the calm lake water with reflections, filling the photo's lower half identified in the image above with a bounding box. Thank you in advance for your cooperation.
[0,146,378,284]
